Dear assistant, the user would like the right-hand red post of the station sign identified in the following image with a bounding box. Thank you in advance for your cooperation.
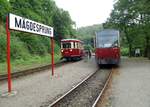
[51,37,54,76]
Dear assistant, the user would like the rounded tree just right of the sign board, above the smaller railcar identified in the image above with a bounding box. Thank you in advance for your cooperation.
[53,9,75,40]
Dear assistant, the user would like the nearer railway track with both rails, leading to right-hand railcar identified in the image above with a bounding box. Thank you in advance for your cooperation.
[45,66,112,107]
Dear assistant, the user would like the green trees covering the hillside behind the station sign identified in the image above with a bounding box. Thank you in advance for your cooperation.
[0,0,76,62]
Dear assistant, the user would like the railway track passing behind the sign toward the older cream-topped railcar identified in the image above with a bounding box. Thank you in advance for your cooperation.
[0,61,71,81]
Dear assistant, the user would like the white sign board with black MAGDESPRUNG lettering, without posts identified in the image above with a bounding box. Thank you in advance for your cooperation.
[9,13,53,37]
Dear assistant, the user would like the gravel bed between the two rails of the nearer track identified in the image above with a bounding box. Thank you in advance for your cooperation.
[52,69,111,107]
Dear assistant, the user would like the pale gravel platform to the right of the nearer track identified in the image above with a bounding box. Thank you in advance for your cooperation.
[99,58,150,107]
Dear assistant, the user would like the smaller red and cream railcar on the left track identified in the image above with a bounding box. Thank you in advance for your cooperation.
[61,39,84,61]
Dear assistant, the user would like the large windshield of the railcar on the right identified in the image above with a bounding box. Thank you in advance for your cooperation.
[97,32,119,48]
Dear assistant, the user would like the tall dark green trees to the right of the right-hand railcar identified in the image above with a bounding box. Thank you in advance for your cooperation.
[104,0,150,57]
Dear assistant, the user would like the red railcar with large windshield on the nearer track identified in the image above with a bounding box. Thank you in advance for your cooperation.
[95,29,120,65]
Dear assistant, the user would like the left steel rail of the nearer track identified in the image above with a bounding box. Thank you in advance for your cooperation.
[48,69,99,107]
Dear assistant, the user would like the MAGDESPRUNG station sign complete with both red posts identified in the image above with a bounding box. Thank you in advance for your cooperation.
[6,13,54,93]
